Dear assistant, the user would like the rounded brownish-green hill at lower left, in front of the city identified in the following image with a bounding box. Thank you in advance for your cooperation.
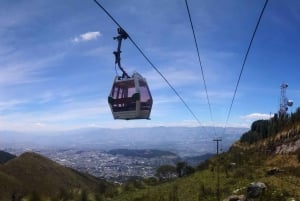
[0,153,113,200]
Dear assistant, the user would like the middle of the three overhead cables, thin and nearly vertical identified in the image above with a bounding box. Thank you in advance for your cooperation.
[185,0,216,135]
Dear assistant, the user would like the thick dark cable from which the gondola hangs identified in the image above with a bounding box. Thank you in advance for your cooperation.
[94,0,201,125]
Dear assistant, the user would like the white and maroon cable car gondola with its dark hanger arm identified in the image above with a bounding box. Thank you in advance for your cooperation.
[108,28,153,120]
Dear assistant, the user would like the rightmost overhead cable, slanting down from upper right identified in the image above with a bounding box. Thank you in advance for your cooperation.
[223,0,269,134]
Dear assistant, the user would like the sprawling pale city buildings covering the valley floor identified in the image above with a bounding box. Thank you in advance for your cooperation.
[5,149,180,182]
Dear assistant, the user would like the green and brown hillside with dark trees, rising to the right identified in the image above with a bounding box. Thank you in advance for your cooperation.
[113,109,300,201]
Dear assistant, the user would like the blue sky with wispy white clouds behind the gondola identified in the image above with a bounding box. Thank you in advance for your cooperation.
[0,0,300,132]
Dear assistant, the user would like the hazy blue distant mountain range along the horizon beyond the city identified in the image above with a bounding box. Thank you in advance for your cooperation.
[0,127,247,157]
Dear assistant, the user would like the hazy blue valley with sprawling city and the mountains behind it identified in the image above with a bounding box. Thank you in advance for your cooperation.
[0,127,245,182]
